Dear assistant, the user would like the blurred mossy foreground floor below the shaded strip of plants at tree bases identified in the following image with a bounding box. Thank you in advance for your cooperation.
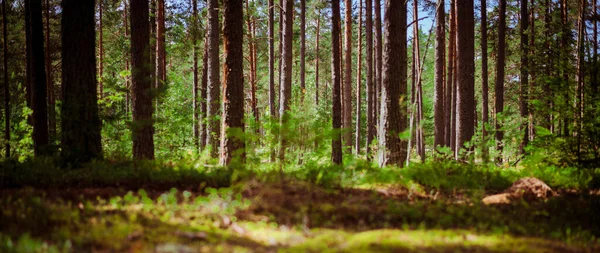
[0,161,600,252]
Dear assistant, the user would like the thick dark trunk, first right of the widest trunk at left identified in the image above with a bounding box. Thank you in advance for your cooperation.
[130,0,154,159]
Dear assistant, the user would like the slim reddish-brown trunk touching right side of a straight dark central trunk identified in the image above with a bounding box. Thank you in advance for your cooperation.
[342,0,352,151]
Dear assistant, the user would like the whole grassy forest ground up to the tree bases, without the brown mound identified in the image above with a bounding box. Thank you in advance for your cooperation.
[0,159,600,252]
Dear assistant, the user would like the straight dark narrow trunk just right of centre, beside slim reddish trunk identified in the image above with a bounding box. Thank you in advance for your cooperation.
[331,0,342,164]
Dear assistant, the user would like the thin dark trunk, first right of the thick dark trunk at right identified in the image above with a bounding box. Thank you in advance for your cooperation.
[480,0,490,162]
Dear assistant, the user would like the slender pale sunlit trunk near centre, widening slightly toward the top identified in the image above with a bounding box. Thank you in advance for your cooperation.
[279,0,294,162]
